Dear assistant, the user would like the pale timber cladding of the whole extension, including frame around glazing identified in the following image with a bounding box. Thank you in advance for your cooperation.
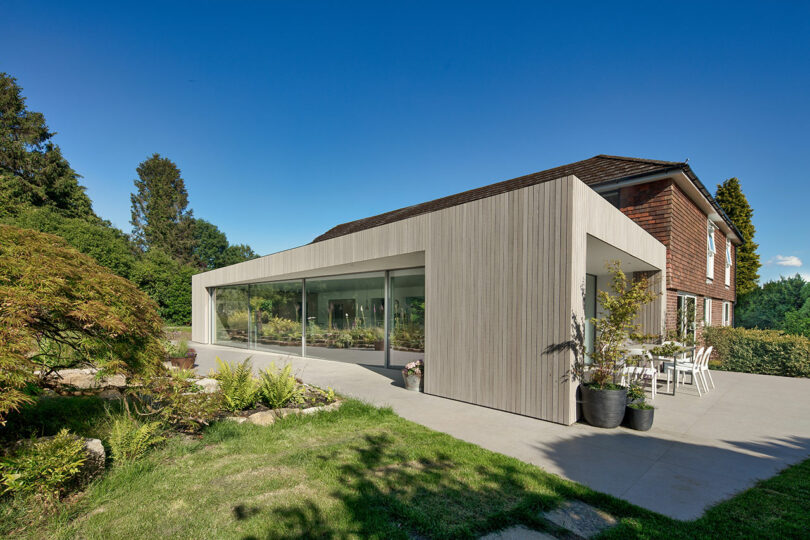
[192,176,666,424]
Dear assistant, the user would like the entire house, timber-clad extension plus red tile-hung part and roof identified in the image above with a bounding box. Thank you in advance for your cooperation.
[192,156,739,424]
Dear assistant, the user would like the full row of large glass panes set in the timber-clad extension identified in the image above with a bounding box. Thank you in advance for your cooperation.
[208,268,425,367]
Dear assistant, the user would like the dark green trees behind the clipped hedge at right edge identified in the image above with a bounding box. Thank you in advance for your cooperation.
[734,274,810,330]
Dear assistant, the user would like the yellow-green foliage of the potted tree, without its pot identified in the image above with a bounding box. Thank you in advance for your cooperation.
[590,261,656,388]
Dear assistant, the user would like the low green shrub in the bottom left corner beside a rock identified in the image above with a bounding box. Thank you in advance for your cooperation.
[0,429,87,498]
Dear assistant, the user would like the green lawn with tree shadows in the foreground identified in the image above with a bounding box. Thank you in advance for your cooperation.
[0,401,810,539]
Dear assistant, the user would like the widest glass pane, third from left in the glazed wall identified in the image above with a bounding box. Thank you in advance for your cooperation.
[306,272,385,366]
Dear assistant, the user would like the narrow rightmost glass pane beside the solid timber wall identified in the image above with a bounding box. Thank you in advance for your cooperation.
[388,268,425,366]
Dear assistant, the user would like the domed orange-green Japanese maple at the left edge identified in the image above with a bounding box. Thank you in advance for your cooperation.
[0,225,165,421]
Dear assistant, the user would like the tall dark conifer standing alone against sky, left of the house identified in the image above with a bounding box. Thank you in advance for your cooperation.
[130,154,194,262]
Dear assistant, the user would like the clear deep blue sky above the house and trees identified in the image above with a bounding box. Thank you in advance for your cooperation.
[0,1,810,279]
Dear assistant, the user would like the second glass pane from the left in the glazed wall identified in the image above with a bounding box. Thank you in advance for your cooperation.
[250,280,303,356]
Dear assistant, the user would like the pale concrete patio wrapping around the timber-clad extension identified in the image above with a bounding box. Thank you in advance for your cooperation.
[191,343,810,520]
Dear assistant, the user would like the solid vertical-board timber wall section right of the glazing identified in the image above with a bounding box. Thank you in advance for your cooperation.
[425,177,576,424]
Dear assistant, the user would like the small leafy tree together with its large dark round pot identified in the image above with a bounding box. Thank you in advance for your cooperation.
[582,261,655,428]
